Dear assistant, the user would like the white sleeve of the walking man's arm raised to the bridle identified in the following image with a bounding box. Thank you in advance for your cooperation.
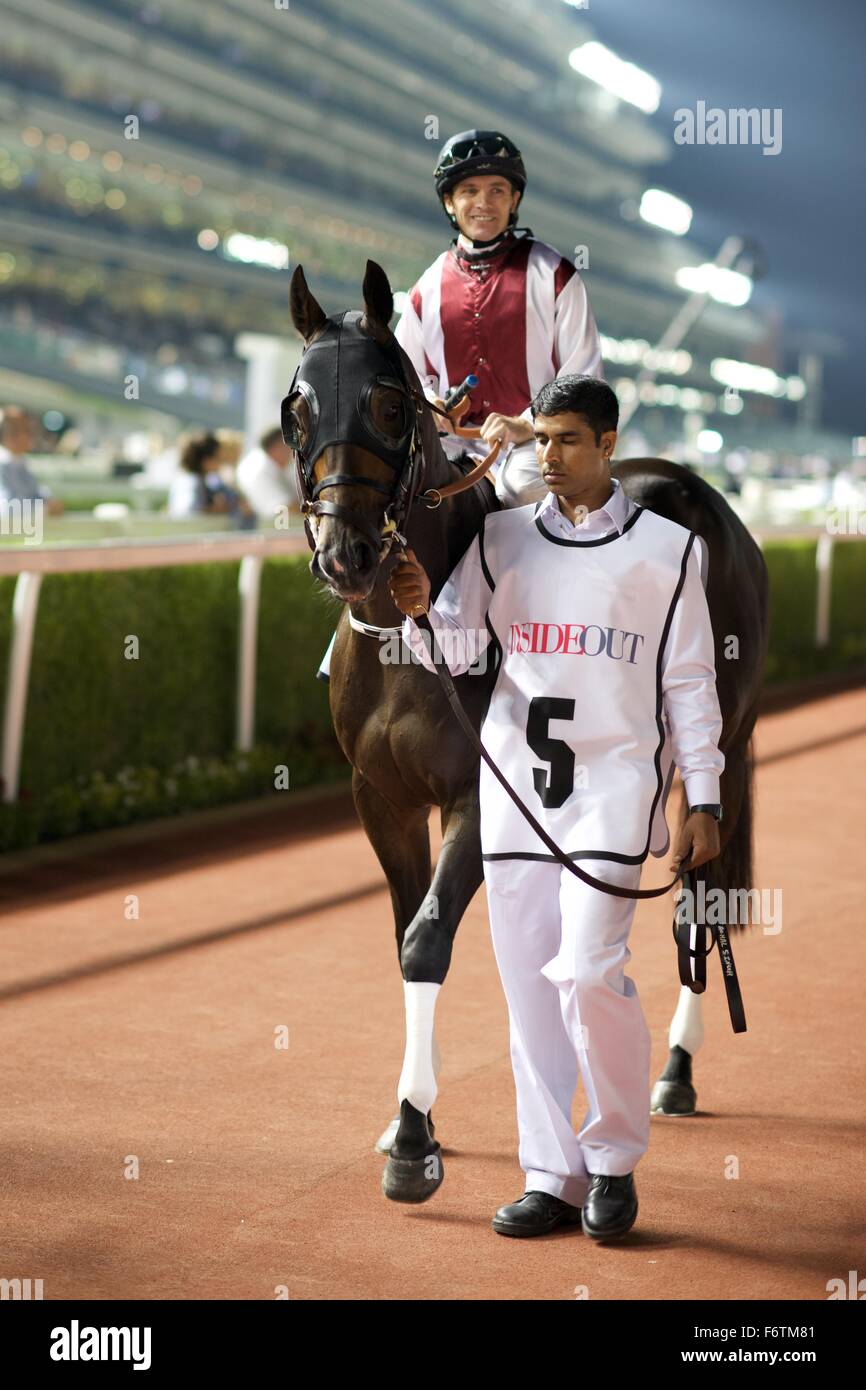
[403,537,492,676]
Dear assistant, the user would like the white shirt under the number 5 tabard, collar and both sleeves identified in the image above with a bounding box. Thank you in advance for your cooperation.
[402,478,724,806]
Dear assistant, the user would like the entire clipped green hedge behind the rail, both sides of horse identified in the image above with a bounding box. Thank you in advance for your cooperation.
[0,541,866,848]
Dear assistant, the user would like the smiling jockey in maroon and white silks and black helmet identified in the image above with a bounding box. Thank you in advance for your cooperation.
[317,131,603,681]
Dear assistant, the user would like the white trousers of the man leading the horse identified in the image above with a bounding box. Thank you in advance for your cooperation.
[484,859,651,1207]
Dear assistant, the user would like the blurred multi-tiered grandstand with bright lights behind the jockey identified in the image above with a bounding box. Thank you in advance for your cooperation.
[0,0,860,521]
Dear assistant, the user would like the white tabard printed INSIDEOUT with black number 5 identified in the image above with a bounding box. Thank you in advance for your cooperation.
[480,505,695,863]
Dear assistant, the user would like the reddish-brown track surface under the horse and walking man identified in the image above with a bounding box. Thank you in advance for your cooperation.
[0,692,866,1300]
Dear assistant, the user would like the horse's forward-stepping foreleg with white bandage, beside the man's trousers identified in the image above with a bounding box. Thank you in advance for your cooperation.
[382,785,484,1202]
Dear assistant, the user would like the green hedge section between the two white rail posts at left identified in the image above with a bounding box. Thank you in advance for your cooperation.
[21,564,240,795]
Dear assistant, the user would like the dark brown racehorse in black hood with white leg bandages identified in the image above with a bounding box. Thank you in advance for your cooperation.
[282,261,767,1202]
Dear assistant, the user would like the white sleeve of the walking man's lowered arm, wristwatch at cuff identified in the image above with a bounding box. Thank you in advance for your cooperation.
[662,538,724,806]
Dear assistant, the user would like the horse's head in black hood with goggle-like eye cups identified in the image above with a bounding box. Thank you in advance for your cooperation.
[282,261,424,600]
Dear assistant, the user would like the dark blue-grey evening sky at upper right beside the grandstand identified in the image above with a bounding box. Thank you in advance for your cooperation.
[575,0,866,435]
